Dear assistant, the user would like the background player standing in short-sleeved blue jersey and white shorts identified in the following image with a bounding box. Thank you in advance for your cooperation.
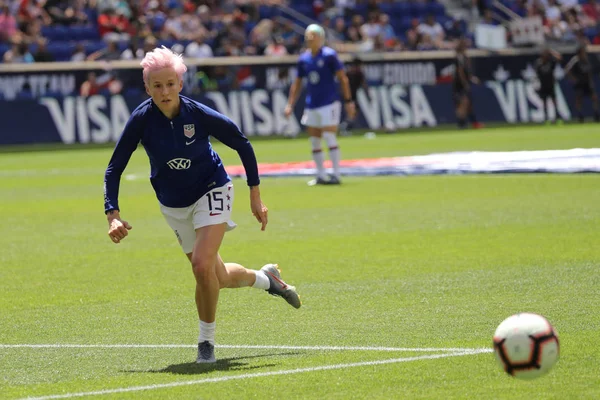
[285,24,356,185]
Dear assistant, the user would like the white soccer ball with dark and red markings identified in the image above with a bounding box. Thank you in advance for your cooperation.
[494,313,559,379]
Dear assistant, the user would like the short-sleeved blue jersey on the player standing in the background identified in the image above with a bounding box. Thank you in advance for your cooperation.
[298,47,344,109]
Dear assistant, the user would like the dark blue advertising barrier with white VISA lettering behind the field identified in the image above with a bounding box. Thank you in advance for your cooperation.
[0,52,600,144]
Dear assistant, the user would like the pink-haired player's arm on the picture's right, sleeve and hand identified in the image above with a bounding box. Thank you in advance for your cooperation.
[206,114,269,231]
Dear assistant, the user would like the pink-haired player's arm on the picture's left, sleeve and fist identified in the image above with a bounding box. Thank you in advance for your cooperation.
[104,111,142,243]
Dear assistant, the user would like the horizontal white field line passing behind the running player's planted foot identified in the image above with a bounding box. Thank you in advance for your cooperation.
[0,343,492,353]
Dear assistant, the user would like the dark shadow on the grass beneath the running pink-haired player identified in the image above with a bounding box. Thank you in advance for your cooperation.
[124,352,299,375]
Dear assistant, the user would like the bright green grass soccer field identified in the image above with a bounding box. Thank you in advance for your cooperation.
[0,125,600,399]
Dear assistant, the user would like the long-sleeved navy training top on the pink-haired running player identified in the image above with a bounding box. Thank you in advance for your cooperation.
[104,96,259,212]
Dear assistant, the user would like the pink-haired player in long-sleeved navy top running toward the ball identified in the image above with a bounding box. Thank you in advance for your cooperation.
[104,47,301,363]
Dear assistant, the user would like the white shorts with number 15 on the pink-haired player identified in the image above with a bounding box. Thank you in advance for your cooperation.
[160,182,237,254]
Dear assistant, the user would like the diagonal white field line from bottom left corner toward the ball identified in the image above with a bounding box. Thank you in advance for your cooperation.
[22,347,489,400]
